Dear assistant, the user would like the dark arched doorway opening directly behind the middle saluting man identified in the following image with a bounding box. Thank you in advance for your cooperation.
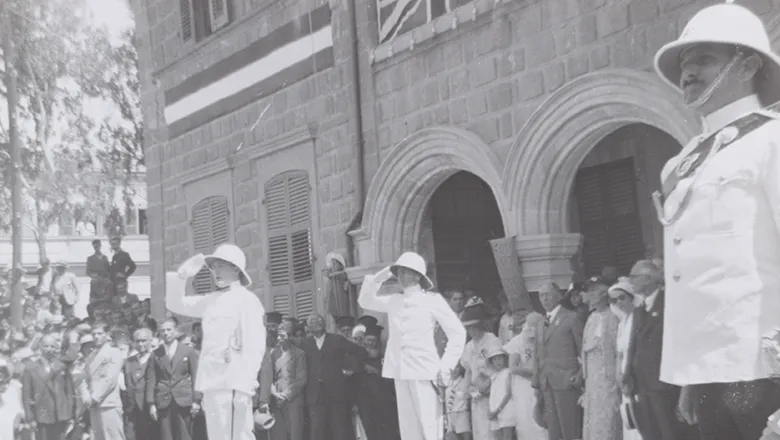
[421,171,504,301]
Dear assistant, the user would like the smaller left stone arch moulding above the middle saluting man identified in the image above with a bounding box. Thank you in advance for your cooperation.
[352,127,508,265]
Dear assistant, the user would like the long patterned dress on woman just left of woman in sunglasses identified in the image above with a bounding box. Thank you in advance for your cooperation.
[582,308,623,440]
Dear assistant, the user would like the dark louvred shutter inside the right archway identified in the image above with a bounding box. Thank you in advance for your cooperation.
[575,158,645,276]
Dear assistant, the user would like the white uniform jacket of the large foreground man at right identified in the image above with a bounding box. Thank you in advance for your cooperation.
[661,116,780,385]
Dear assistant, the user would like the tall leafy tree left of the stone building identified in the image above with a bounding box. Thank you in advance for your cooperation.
[0,0,143,258]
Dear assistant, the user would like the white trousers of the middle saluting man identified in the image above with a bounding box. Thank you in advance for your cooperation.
[395,379,444,440]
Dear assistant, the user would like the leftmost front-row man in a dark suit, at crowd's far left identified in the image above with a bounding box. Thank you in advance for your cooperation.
[22,334,76,440]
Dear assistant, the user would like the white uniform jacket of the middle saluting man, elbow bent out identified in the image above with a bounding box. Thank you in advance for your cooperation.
[358,275,466,380]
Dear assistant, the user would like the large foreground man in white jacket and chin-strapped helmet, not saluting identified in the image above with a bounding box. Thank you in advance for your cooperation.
[654,4,780,440]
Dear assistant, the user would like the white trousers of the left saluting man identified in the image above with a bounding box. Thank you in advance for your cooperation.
[203,390,255,440]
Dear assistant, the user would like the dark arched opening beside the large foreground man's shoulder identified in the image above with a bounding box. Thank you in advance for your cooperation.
[568,123,681,276]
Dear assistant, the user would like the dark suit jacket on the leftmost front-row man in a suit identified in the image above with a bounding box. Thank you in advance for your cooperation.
[22,359,77,424]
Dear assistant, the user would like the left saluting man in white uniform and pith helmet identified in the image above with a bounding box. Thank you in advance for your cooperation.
[165,244,265,440]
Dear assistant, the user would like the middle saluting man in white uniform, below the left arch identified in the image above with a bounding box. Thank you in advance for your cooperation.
[358,252,466,440]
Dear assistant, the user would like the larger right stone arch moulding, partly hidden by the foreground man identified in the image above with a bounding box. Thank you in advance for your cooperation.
[503,69,700,235]
